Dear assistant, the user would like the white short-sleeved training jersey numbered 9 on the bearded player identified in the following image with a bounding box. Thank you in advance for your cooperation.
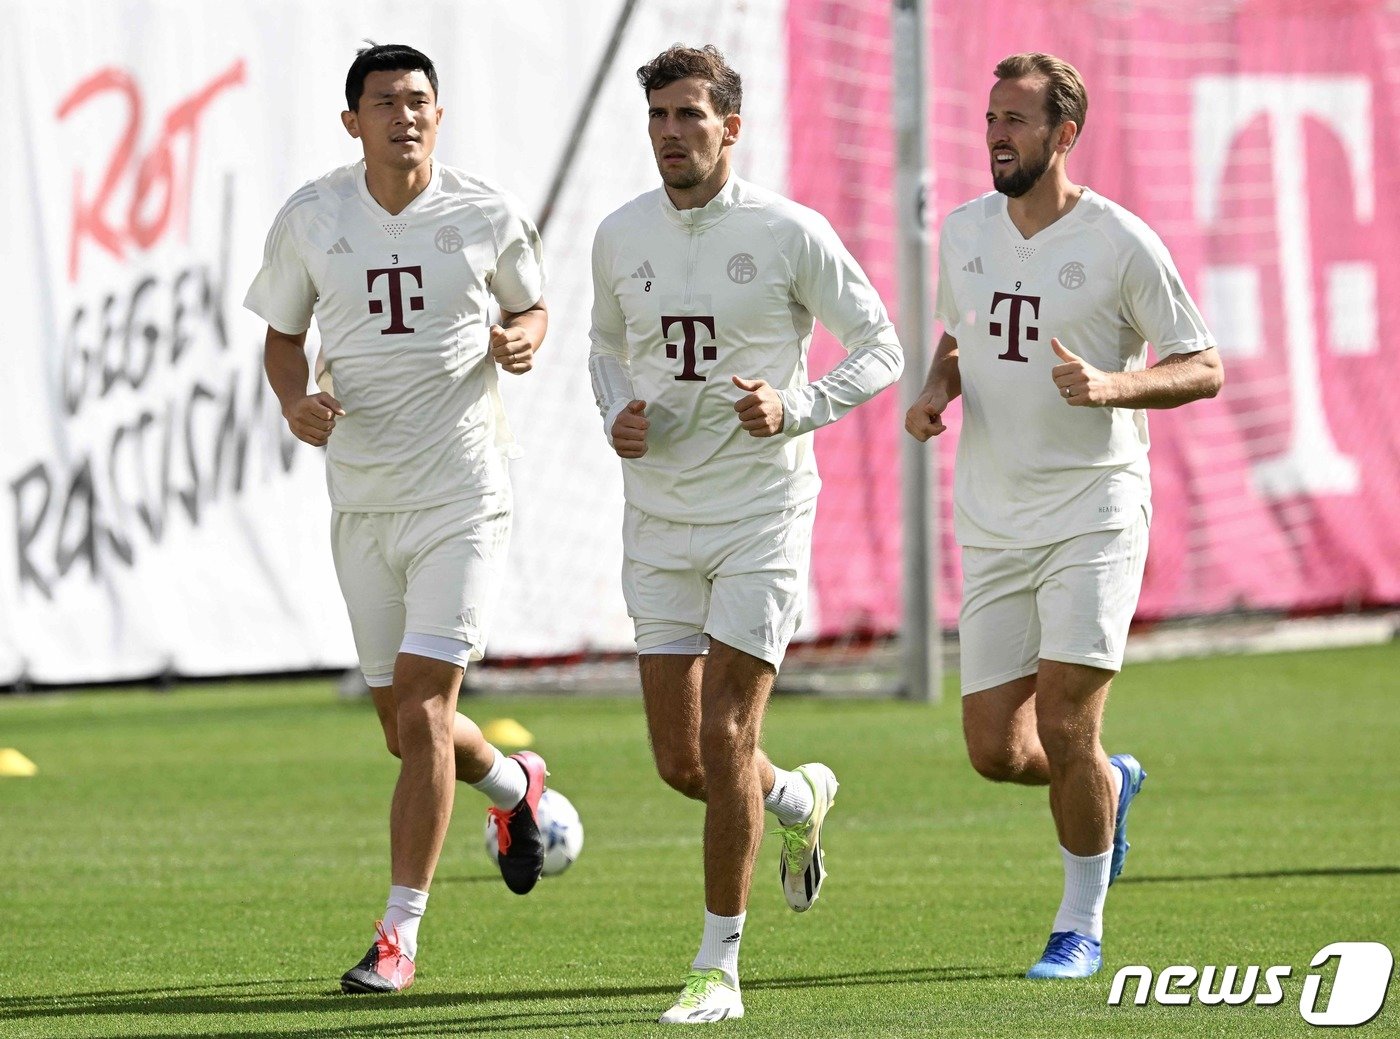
[937,189,1215,548]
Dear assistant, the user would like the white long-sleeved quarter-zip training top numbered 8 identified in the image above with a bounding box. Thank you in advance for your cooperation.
[589,176,903,524]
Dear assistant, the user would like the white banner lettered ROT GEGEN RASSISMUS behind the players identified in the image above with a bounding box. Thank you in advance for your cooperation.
[0,0,787,683]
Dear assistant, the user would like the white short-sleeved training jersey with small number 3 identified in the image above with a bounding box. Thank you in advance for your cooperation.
[244,161,543,512]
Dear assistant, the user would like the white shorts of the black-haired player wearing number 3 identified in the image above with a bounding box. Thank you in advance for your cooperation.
[330,489,511,686]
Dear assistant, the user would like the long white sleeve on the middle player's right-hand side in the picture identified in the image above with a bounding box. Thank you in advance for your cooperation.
[778,217,904,437]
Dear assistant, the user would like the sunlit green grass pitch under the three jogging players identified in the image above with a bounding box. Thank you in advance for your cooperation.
[0,644,1400,1039]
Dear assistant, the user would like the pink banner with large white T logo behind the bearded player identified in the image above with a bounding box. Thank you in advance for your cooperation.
[790,0,1400,634]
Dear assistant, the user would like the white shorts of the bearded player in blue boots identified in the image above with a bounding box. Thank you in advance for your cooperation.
[958,512,1147,696]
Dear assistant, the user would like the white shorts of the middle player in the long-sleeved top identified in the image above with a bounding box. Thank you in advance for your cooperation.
[622,500,816,668]
